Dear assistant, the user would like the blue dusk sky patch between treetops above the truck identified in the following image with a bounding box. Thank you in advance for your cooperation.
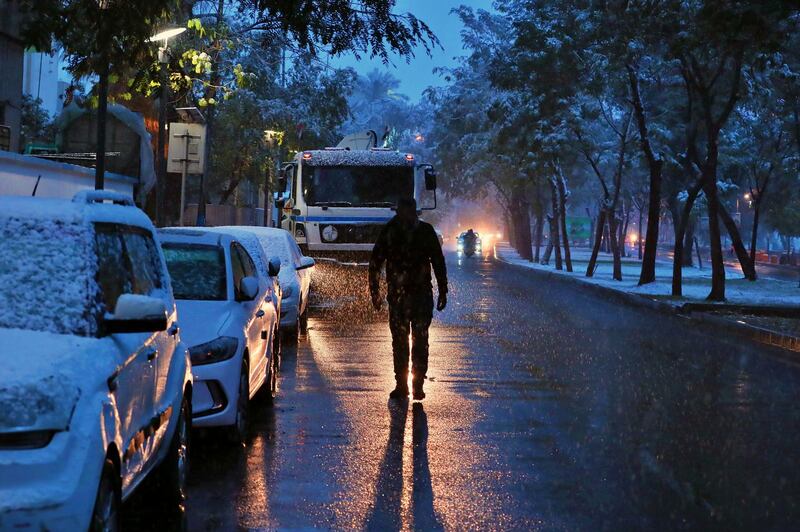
[331,0,492,100]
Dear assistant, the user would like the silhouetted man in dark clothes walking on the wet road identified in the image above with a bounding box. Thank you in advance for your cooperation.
[369,198,447,400]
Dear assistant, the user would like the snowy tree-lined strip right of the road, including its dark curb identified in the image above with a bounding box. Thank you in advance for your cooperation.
[494,242,800,361]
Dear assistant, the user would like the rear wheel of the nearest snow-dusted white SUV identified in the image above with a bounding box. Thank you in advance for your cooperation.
[156,397,192,516]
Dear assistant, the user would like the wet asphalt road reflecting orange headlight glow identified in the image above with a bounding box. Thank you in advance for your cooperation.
[173,251,800,530]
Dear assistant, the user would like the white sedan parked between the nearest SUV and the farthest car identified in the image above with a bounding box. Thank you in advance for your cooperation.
[160,228,279,443]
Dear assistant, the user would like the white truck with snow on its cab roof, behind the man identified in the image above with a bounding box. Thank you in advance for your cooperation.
[275,131,436,262]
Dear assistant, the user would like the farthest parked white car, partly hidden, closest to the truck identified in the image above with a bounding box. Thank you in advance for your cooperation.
[220,225,316,341]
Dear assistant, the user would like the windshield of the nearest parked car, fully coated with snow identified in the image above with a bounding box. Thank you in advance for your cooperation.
[0,218,97,336]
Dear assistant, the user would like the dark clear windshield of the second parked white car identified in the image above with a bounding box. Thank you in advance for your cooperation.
[161,242,227,301]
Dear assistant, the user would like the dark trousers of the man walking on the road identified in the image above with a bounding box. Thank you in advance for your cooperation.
[389,292,433,384]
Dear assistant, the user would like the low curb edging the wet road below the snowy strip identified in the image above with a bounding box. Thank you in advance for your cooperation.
[494,247,800,362]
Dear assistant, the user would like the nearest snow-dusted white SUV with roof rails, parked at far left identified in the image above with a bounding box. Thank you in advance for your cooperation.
[0,191,192,530]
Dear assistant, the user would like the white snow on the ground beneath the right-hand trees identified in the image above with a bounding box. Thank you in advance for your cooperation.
[495,243,800,306]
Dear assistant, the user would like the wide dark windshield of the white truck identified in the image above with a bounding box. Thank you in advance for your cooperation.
[303,166,414,207]
